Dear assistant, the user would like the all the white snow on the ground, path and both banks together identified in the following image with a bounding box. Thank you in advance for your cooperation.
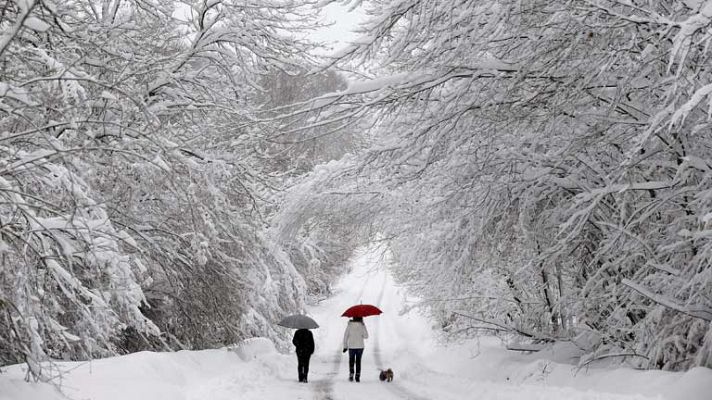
[0,245,712,400]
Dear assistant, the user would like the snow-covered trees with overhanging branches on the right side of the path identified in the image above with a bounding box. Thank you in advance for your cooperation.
[288,0,712,369]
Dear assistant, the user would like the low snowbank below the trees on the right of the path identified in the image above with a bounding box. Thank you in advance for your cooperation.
[433,338,712,400]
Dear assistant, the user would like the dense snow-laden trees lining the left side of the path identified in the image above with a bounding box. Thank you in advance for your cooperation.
[0,0,318,376]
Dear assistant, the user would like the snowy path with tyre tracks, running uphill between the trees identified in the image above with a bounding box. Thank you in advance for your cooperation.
[310,244,429,400]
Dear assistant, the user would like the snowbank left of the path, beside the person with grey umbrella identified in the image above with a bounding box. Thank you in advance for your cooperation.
[0,338,298,400]
